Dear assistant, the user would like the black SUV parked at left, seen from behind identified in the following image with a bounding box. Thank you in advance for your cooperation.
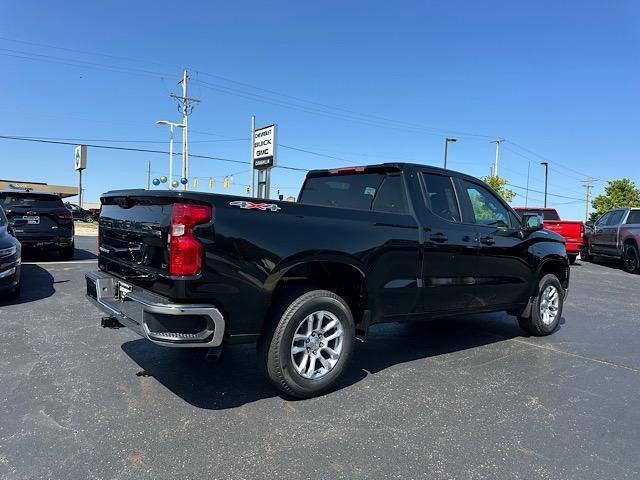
[0,190,74,259]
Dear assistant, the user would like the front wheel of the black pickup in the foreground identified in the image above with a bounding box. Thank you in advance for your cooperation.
[518,274,564,337]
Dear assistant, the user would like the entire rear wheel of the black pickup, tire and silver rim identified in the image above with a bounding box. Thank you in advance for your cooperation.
[258,290,355,398]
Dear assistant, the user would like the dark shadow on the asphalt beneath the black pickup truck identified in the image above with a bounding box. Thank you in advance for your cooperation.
[122,314,523,410]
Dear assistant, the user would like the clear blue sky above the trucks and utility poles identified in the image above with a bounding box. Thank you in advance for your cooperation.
[0,0,640,219]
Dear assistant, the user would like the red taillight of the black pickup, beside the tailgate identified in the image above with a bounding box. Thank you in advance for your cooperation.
[169,203,212,275]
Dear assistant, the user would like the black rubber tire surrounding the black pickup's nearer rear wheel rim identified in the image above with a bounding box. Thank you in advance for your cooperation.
[258,290,355,398]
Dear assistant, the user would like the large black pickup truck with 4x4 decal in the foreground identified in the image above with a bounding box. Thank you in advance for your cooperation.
[86,163,569,397]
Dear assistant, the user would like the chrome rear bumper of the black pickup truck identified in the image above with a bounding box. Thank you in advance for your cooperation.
[85,271,225,347]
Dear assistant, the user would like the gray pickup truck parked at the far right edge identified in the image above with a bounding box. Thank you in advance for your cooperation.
[583,208,640,273]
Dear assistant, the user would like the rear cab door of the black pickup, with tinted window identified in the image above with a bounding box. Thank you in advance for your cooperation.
[415,170,479,316]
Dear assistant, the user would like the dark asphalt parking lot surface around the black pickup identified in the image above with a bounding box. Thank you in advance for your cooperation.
[0,237,640,480]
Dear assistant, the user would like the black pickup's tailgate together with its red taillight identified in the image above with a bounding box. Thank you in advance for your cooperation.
[98,190,212,298]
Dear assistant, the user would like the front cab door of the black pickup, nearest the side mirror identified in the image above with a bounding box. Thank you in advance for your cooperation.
[458,179,532,310]
